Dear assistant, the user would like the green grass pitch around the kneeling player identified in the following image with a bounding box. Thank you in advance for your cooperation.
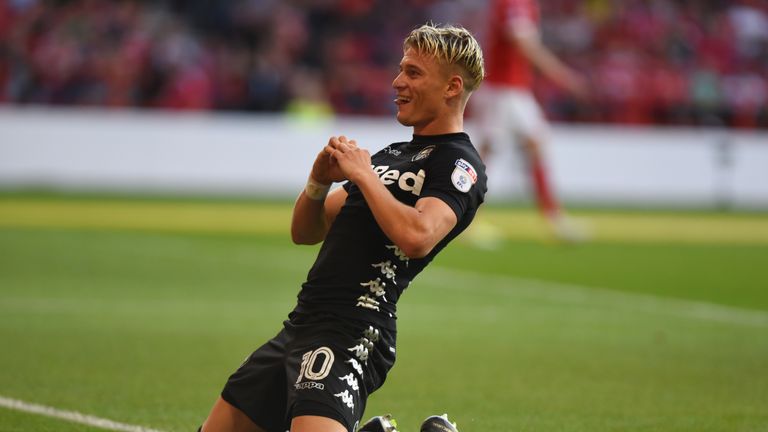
[0,194,768,432]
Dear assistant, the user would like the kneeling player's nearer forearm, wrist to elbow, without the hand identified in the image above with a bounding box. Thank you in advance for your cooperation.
[356,172,437,258]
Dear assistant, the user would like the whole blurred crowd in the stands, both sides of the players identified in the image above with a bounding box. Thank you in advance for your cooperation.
[0,0,768,128]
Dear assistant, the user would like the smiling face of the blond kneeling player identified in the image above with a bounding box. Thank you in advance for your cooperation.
[392,48,449,134]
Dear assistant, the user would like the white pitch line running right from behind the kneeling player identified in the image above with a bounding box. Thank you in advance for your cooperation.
[425,266,768,327]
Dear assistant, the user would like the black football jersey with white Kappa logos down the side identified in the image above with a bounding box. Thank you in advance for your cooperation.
[295,133,487,329]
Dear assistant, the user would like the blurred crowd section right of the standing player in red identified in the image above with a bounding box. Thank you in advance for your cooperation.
[537,0,768,128]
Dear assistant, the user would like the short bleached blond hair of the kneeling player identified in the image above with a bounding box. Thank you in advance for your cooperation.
[403,23,485,92]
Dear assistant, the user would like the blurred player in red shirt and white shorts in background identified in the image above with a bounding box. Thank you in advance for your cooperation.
[472,0,589,241]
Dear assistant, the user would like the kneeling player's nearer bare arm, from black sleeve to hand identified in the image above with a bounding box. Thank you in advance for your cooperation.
[326,139,457,258]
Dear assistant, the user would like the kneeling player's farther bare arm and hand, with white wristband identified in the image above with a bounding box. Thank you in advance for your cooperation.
[291,137,347,244]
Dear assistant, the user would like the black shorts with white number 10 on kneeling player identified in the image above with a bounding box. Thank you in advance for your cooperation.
[221,314,395,432]
